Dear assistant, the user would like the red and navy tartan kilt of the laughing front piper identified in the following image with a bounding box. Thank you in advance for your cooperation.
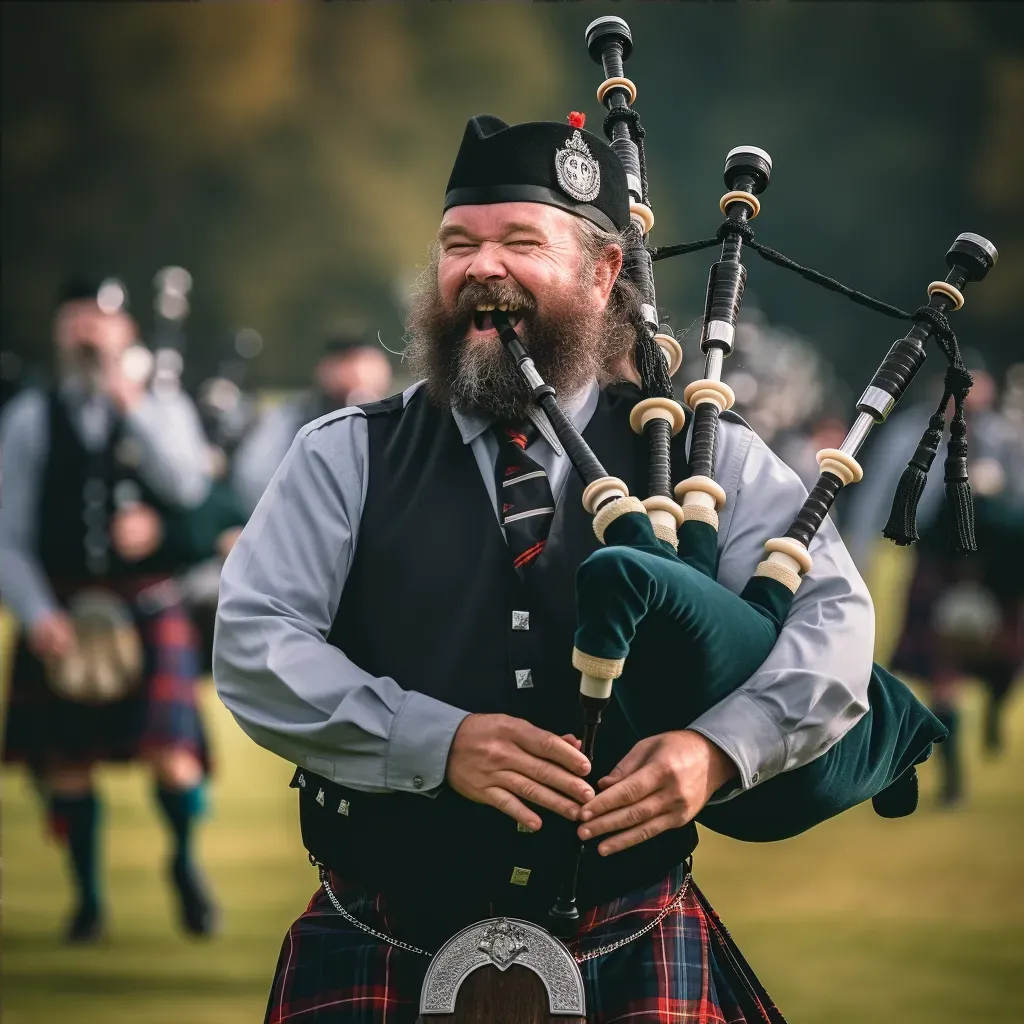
[264,865,784,1024]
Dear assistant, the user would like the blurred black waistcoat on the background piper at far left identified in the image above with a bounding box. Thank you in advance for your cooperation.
[36,392,173,584]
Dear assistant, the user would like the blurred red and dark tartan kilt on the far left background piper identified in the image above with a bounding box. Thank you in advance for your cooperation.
[2,581,210,771]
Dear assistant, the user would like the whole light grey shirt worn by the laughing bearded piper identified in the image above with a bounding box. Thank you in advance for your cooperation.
[213,384,874,795]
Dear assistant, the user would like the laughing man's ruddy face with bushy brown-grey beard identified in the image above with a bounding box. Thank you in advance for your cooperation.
[410,203,622,418]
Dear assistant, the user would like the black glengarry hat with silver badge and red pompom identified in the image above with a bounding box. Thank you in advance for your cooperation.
[444,114,630,231]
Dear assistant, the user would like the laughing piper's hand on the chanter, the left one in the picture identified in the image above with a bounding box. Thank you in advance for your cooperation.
[445,715,594,831]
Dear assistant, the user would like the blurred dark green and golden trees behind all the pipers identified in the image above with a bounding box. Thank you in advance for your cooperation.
[0,3,1024,384]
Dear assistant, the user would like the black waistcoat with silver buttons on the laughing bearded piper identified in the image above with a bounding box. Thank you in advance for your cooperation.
[293,387,696,920]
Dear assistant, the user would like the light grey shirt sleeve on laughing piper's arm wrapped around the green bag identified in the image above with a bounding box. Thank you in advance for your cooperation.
[691,422,874,799]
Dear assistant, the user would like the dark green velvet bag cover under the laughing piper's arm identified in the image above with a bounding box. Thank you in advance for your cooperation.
[574,513,945,842]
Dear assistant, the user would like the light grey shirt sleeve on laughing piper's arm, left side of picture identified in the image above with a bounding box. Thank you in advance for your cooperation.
[213,410,468,796]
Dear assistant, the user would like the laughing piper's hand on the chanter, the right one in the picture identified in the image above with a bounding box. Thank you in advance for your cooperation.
[579,729,736,857]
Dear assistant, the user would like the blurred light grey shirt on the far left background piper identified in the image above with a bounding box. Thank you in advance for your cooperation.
[0,386,210,628]
